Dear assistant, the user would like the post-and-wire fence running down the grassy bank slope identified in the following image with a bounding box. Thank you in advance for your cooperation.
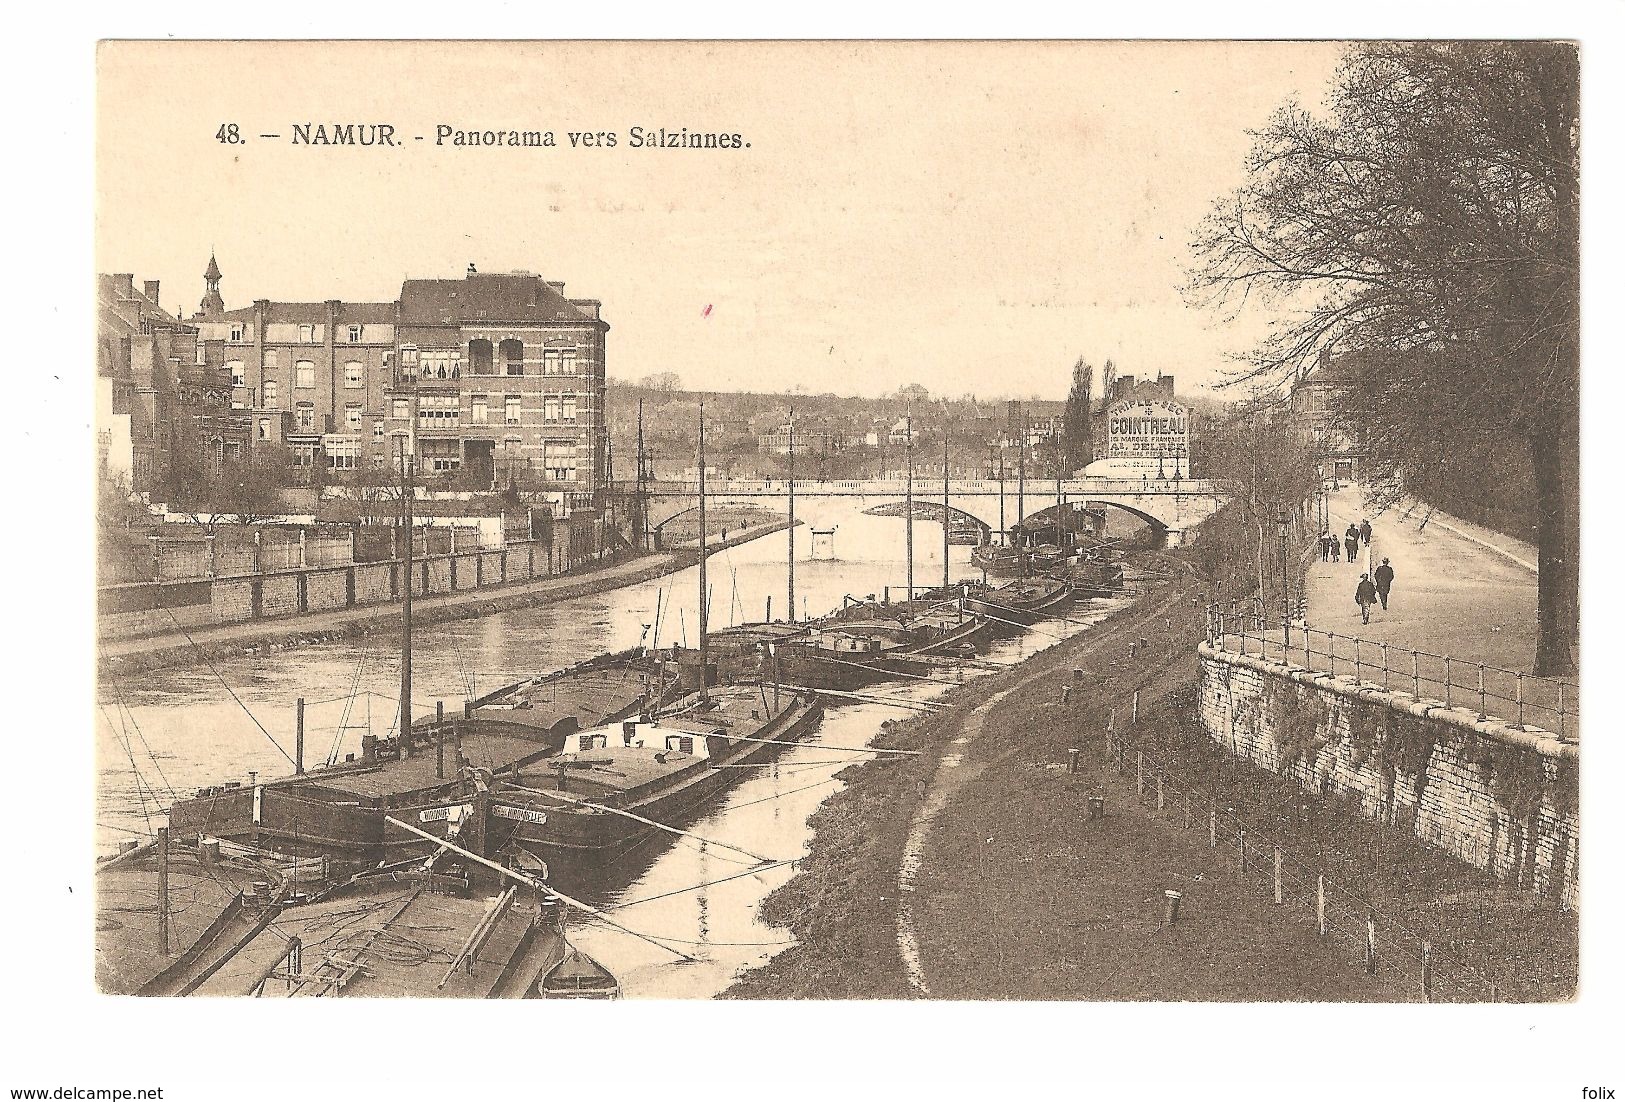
[1107,730,1521,1003]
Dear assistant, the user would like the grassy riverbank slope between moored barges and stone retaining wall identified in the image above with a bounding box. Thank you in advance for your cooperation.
[726,556,1576,1001]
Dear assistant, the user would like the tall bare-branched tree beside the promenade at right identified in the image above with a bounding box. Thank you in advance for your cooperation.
[1191,42,1580,675]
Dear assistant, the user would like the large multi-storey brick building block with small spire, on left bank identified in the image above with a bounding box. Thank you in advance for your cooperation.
[190,258,609,510]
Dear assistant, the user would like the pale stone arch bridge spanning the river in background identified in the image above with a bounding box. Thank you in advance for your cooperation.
[633,478,1230,544]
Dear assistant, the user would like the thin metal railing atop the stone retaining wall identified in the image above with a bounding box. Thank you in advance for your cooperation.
[1207,598,1580,740]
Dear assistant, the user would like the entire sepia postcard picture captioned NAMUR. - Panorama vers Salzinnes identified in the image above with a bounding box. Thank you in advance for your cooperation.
[7,21,1612,1097]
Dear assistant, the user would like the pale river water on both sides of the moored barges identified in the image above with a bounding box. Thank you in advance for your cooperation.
[96,510,1137,998]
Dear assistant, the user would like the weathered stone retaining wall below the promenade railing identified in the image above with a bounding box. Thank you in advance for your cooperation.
[1198,642,1580,907]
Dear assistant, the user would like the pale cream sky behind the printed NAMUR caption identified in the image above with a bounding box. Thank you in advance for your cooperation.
[96,42,1342,406]
